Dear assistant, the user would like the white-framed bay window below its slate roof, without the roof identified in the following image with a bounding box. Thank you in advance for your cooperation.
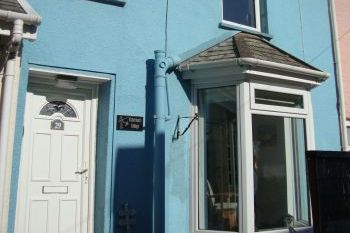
[193,82,313,233]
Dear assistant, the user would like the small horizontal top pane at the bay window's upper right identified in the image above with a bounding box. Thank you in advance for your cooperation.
[255,89,304,108]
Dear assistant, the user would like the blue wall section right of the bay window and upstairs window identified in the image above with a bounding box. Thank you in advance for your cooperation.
[268,0,340,150]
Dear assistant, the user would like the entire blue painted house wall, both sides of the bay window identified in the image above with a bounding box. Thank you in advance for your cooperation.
[9,0,339,233]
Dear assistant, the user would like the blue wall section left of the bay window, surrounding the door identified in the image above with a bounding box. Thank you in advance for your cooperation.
[9,0,227,232]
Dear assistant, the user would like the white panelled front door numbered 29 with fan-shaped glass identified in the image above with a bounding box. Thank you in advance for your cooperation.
[16,84,96,233]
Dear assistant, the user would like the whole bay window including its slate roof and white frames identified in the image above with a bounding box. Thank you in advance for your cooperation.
[177,31,328,233]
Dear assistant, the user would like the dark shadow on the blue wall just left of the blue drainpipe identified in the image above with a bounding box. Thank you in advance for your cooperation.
[112,59,154,233]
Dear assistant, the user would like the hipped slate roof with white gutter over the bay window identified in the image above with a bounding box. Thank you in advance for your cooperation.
[177,32,328,87]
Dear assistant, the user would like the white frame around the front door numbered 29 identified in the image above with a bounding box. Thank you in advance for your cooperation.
[15,68,106,233]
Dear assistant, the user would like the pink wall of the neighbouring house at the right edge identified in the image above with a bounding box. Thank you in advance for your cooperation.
[334,0,350,120]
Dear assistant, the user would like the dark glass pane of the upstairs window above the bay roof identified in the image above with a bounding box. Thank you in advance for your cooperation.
[223,0,256,27]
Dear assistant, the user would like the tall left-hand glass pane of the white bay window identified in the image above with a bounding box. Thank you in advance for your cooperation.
[198,87,239,231]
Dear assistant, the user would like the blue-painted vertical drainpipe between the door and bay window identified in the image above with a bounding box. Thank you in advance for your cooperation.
[153,50,179,233]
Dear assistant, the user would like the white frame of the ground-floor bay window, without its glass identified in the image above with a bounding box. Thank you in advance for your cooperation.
[190,77,315,233]
